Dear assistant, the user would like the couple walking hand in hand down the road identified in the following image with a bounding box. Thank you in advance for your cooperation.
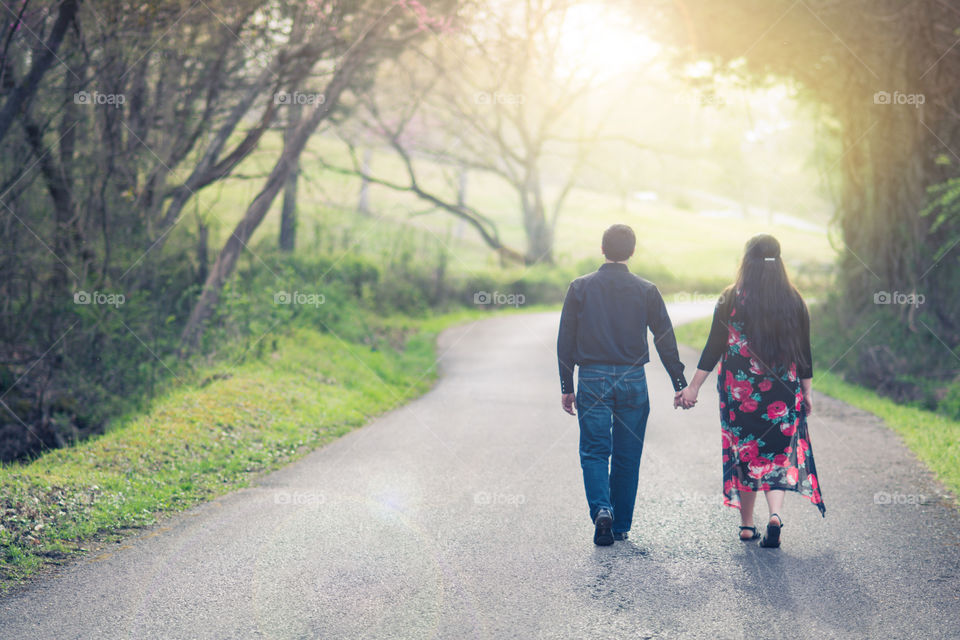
[557,224,825,547]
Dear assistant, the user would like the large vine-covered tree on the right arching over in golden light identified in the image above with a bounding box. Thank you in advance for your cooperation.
[656,0,960,390]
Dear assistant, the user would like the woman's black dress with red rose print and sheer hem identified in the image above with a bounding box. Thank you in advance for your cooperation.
[698,290,826,515]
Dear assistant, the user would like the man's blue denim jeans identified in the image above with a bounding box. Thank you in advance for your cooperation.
[577,365,650,533]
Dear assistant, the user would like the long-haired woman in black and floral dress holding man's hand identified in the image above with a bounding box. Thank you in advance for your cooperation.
[678,234,826,547]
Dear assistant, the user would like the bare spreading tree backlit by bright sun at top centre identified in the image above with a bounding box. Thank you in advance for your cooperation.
[337,0,636,264]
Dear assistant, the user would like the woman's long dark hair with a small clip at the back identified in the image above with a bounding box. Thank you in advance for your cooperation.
[731,233,810,372]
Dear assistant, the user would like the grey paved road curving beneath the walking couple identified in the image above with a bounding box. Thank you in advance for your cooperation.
[0,305,960,640]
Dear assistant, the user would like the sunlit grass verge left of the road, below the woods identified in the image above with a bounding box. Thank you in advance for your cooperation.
[0,310,496,593]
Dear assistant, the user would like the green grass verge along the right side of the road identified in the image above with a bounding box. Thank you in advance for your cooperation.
[675,318,960,501]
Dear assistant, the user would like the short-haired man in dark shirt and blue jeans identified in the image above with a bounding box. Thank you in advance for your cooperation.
[557,224,687,546]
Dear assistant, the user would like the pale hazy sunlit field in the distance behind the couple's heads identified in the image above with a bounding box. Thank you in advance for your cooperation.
[182,136,836,286]
